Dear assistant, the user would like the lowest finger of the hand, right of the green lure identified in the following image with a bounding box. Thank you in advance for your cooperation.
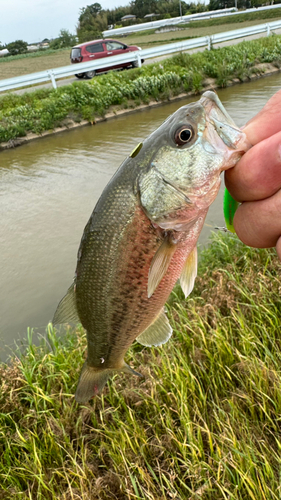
[234,190,281,249]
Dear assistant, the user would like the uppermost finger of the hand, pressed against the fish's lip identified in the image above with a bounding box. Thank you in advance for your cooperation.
[243,90,281,145]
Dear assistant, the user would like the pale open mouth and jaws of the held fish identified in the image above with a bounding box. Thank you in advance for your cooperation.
[200,90,251,170]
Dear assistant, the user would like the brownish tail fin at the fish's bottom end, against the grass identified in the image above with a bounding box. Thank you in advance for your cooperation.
[75,361,113,403]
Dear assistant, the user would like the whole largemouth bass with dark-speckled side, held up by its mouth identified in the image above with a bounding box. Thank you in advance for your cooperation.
[53,91,249,403]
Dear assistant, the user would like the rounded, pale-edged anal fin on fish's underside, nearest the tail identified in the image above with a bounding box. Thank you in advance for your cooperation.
[136,309,173,347]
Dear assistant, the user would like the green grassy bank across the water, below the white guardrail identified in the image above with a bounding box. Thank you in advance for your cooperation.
[0,36,281,144]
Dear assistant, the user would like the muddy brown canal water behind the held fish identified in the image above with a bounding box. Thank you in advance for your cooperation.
[0,74,281,359]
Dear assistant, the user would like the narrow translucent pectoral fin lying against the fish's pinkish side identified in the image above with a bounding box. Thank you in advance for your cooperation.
[147,236,176,298]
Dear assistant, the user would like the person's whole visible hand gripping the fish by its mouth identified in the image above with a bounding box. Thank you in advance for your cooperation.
[225,90,281,260]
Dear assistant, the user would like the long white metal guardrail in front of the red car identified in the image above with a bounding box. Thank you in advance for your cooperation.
[0,21,281,92]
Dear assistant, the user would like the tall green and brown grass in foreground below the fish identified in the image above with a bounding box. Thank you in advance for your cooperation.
[0,234,281,500]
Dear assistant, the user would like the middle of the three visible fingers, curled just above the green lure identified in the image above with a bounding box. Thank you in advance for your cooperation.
[225,133,281,201]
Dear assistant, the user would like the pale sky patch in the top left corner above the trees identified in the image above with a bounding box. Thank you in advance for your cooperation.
[0,0,125,45]
